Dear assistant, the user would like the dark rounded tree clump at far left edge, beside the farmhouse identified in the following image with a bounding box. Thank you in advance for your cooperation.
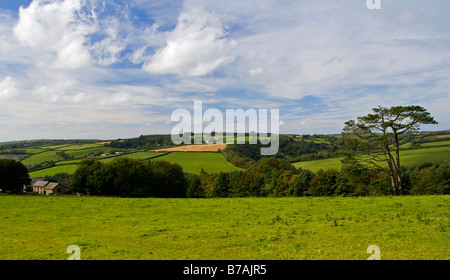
[0,159,31,194]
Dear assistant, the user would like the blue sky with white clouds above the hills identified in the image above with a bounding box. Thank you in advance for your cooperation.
[0,0,450,141]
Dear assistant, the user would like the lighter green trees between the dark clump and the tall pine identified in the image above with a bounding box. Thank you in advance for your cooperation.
[187,157,391,197]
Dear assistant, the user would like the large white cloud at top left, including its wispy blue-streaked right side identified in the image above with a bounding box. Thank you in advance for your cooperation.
[14,0,126,69]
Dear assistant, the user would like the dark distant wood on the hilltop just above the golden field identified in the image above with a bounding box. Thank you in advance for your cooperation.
[105,135,174,150]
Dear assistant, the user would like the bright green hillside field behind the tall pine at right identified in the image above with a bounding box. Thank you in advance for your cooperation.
[293,146,450,171]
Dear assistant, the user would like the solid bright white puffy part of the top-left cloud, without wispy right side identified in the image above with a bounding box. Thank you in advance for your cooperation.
[14,0,95,68]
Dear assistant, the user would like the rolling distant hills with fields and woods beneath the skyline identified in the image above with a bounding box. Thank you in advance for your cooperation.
[0,129,450,176]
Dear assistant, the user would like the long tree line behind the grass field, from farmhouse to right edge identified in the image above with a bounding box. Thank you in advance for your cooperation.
[70,157,450,198]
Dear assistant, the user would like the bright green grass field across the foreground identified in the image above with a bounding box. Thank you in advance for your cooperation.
[0,195,450,260]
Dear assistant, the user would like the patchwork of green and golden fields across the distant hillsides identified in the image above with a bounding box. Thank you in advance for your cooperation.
[0,130,450,177]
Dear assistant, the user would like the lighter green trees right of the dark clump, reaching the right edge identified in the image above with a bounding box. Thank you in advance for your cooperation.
[186,157,450,198]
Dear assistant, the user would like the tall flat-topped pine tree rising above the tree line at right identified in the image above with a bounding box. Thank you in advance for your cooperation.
[343,106,437,195]
